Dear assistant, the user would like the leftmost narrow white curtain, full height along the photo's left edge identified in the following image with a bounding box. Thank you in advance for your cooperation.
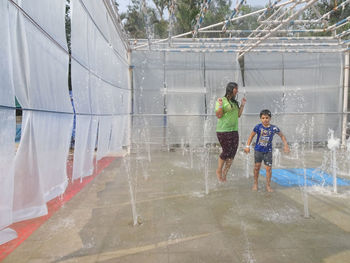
[0,0,17,245]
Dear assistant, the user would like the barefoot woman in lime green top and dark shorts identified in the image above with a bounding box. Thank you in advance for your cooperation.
[215,82,246,182]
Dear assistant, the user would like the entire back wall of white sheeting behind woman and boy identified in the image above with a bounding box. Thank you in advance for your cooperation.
[132,51,343,144]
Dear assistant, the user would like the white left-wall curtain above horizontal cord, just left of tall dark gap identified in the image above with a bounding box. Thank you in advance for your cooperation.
[9,0,72,112]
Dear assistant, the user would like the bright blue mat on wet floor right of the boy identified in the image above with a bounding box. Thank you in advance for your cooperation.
[260,168,350,187]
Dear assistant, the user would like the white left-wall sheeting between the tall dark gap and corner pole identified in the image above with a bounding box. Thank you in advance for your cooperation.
[71,0,130,185]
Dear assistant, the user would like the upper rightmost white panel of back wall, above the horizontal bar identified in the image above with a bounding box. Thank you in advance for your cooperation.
[284,53,342,112]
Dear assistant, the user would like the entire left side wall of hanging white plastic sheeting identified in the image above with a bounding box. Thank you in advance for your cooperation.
[0,0,130,248]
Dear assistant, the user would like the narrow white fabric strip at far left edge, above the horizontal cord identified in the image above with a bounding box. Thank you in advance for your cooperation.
[0,1,15,106]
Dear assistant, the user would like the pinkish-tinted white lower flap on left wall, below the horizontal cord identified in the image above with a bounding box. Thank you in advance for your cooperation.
[13,111,47,222]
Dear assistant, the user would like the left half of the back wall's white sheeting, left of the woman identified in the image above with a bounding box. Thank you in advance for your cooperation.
[132,51,242,145]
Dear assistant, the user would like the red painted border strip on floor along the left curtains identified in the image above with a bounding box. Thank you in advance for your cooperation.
[0,157,116,261]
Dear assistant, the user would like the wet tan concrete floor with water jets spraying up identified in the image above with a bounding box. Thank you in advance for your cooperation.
[3,148,350,263]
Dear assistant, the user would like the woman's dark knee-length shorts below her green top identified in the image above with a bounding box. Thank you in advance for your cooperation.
[216,131,239,160]
